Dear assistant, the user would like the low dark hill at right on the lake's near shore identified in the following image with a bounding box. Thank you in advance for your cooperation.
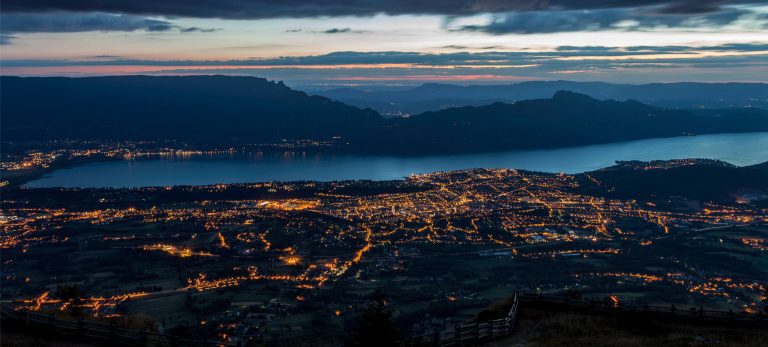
[577,159,768,202]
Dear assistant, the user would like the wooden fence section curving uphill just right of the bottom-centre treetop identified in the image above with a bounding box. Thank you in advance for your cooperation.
[410,293,520,347]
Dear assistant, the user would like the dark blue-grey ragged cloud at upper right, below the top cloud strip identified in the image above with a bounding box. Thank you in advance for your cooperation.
[447,8,768,35]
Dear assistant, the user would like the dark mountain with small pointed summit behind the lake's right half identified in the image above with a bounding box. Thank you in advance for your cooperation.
[358,91,768,153]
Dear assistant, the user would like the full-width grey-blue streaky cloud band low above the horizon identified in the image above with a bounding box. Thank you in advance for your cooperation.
[0,43,768,84]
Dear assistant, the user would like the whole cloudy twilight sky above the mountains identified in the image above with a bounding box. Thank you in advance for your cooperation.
[0,0,768,86]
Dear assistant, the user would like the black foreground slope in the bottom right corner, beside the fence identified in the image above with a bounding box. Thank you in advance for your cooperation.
[488,307,768,347]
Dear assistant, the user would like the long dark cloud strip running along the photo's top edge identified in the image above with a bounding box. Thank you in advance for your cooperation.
[2,0,764,19]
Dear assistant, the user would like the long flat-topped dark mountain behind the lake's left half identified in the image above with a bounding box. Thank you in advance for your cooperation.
[0,76,381,143]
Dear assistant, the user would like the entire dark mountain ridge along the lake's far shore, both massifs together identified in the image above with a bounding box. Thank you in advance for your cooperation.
[0,76,768,155]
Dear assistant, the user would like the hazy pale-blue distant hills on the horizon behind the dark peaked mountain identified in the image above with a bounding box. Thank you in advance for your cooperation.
[313,81,768,114]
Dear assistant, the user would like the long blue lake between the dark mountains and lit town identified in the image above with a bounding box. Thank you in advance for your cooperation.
[25,133,768,188]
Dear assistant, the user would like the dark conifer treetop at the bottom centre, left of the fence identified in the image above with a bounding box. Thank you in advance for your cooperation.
[347,290,400,347]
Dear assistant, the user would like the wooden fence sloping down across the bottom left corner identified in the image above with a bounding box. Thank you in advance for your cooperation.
[0,305,241,347]
